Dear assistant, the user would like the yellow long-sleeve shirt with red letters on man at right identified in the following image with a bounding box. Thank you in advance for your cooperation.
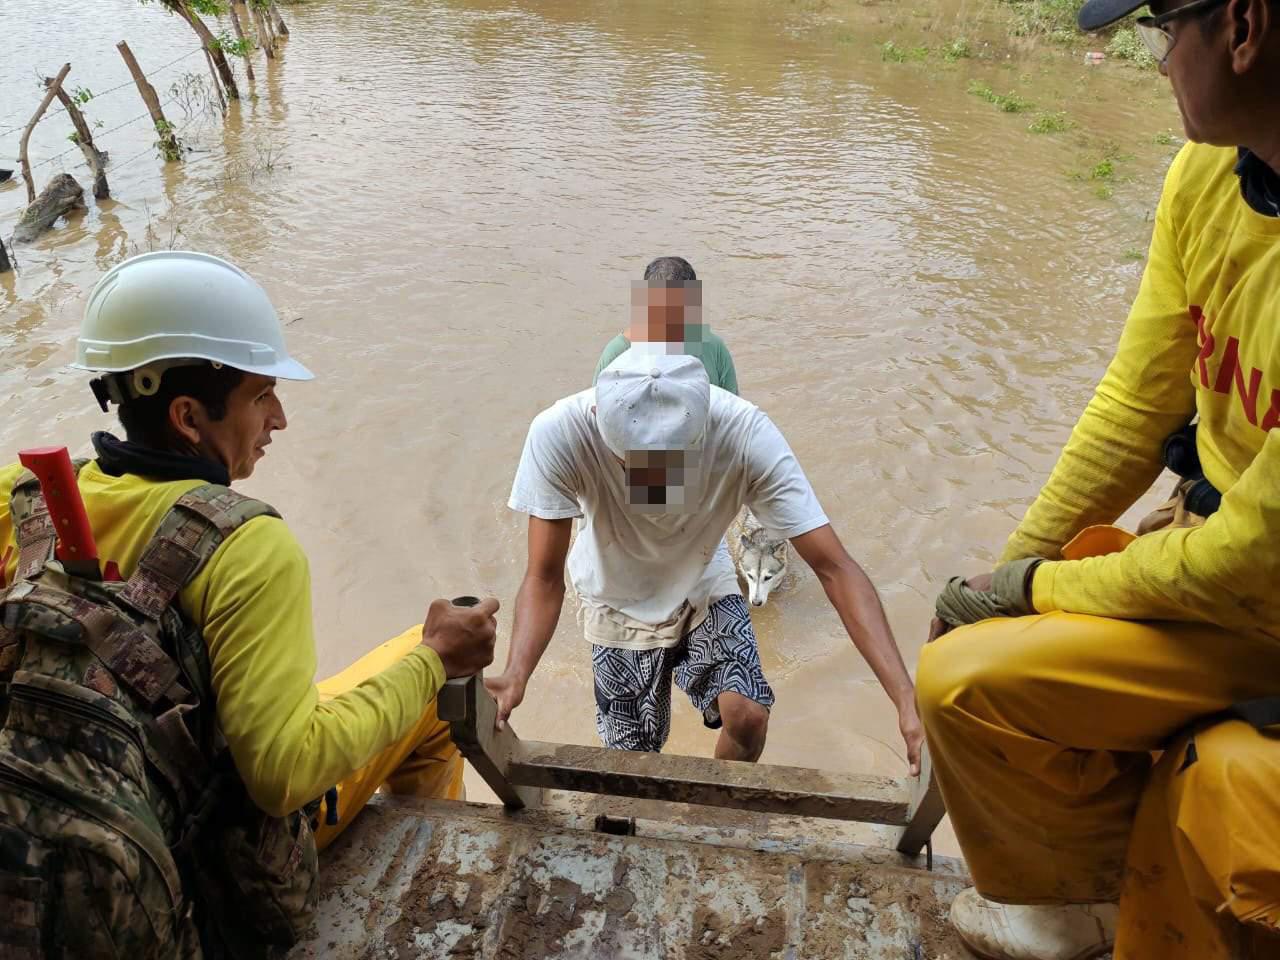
[1004,145,1280,640]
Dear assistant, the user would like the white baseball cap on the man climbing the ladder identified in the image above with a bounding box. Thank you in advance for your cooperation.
[595,347,712,460]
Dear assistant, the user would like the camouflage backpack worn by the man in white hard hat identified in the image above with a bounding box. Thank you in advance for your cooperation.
[0,471,319,960]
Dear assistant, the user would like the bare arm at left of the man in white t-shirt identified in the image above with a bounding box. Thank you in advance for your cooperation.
[485,516,573,730]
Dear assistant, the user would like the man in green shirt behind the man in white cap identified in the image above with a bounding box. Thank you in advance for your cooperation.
[591,257,737,396]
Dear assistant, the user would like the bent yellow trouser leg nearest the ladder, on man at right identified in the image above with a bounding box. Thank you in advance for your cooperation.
[918,613,1280,960]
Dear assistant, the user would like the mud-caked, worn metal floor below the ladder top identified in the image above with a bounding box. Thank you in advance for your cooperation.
[291,797,969,960]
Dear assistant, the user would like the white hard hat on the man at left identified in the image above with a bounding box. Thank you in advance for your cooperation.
[72,250,314,380]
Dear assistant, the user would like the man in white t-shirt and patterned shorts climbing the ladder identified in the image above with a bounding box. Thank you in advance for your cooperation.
[485,344,923,773]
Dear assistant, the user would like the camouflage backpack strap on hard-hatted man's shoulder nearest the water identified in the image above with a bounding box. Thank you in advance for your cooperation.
[120,484,280,621]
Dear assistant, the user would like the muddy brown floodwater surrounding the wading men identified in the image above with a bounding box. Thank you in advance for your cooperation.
[0,0,1178,839]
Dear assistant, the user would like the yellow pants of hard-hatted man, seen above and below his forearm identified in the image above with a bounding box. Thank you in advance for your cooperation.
[307,623,463,850]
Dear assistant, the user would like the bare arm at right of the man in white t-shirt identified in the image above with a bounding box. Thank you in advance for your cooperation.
[783,524,924,776]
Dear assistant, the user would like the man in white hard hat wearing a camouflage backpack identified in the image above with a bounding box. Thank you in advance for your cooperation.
[0,252,498,957]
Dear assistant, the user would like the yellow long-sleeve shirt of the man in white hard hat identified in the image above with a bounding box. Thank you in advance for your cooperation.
[0,462,444,815]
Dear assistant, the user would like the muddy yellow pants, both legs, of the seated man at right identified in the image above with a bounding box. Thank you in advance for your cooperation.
[916,613,1280,960]
